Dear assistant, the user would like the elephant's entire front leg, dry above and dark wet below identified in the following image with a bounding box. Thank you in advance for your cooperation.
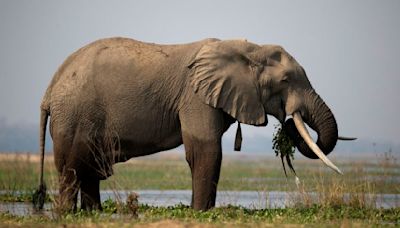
[179,100,226,210]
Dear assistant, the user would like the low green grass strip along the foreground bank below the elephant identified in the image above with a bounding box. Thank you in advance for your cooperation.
[0,201,400,227]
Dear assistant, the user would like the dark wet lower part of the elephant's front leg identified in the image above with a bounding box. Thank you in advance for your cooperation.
[185,134,222,211]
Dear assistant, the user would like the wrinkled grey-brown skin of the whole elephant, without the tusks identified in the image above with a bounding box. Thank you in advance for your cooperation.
[37,38,338,210]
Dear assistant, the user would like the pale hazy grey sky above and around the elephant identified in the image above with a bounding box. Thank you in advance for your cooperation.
[0,0,400,143]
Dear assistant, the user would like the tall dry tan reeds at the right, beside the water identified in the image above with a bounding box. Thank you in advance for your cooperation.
[289,153,400,209]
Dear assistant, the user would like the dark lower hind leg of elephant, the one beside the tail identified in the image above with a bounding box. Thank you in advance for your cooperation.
[56,169,79,214]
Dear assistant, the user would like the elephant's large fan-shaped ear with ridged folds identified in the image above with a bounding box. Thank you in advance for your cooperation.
[189,41,267,125]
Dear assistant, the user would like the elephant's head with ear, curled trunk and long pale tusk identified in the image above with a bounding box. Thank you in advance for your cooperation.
[190,40,346,172]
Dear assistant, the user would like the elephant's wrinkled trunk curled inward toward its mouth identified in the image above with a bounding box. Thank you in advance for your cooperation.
[285,90,338,159]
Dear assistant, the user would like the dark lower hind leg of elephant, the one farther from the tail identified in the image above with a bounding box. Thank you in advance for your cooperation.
[81,178,102,211]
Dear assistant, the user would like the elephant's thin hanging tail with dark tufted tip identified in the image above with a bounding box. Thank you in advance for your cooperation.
[32,108,49,210]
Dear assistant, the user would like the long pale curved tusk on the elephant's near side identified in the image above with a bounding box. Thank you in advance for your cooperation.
[293,112,343,175]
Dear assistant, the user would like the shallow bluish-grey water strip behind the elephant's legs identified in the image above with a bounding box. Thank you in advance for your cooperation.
[0,190,400,216]
